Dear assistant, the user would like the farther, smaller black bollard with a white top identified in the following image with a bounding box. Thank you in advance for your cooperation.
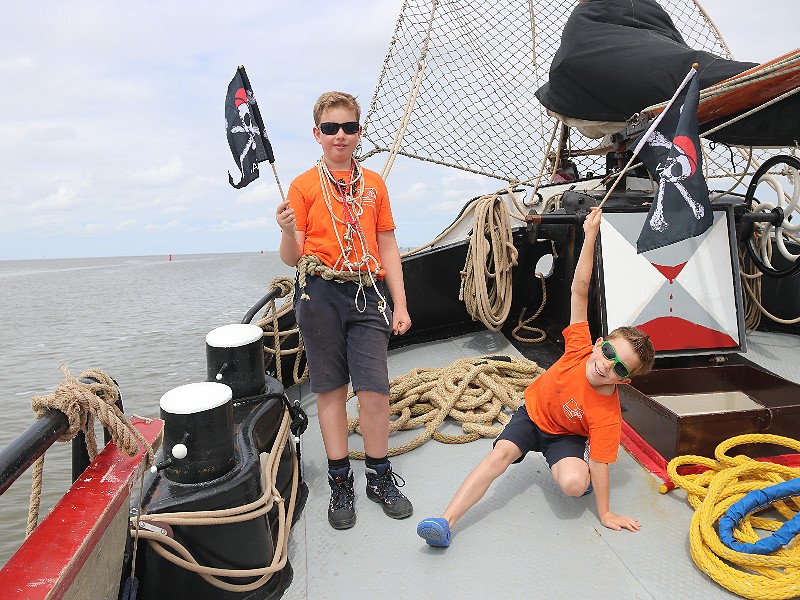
[206,324,266,400]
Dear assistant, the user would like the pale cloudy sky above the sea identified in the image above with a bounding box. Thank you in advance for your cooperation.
[0,0,800,260]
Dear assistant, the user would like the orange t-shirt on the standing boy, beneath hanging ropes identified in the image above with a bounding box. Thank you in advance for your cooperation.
[288,167,395,279]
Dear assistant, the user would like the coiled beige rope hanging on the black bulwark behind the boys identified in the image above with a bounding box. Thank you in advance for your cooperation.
[458,188,518,331]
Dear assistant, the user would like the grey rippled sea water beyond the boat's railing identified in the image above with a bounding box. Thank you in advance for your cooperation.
[0,252,293,566]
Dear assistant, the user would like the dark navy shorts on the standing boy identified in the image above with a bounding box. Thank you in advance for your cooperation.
[294,276,392,395]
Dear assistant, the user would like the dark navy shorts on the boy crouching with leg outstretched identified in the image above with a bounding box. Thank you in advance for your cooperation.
[494,402,589,469]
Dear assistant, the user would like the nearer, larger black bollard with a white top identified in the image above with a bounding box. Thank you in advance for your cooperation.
[151,382,235,483]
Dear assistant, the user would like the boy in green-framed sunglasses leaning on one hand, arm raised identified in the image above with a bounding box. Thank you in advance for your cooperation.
[417,209,655,546]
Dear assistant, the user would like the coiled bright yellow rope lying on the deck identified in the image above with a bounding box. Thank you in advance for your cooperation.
[667,434,800,600]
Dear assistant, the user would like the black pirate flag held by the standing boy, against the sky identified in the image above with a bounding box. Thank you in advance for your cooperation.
[225,66,275,189]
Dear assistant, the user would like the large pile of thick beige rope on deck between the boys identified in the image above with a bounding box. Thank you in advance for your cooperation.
[347,355,544,460]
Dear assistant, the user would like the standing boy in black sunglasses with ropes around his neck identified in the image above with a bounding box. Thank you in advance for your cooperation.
[276,92,413,529]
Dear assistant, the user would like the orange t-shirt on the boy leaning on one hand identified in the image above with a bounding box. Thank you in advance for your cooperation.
[525,321,622,463]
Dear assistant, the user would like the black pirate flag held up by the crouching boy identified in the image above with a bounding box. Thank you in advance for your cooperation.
[636,70,714,254]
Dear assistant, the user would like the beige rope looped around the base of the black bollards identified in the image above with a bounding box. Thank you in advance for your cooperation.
[132,410,299,593]
